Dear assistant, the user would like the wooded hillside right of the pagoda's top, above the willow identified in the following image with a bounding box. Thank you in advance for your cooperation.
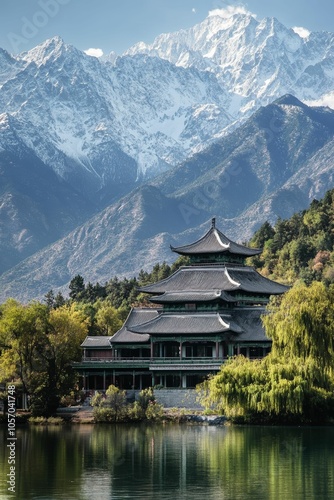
[250,190,334,285]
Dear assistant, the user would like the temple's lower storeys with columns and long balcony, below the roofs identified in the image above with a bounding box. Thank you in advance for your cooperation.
[75,341,271,391]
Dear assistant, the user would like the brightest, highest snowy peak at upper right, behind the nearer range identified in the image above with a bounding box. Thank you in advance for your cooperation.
[126,13,334,119]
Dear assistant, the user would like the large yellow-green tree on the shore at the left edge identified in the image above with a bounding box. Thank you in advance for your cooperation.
[0,299,88,416]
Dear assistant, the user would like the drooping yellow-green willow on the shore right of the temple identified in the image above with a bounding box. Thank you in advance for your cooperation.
[200,282,334,422]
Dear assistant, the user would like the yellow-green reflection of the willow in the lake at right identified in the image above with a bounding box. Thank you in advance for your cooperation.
[199,427,334,500]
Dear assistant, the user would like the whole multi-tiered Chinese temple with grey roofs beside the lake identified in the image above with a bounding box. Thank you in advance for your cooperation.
[75,219,287,390]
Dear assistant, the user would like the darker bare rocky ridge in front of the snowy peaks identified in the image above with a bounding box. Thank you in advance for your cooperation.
[0,95,334,300]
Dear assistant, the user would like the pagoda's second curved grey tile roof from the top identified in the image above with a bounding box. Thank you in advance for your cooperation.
[140,265,288,294]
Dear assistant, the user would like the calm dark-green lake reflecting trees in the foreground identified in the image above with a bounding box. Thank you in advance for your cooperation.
[0,424,334,500]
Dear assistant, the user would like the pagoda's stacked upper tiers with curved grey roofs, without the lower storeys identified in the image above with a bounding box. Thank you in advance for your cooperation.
[110,219,287,344]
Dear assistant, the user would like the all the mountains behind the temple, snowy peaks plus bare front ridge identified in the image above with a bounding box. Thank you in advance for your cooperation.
[0,14,334,300]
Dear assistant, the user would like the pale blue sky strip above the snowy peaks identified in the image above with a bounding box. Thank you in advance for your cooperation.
[0,0,334,54]
